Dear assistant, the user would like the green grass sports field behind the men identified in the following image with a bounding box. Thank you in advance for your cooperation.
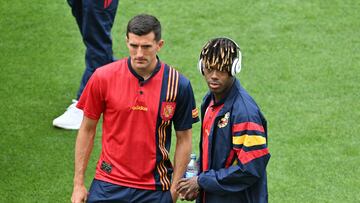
[0,0,360,203]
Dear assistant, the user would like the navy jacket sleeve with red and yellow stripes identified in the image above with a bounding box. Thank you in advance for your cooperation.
[198,112,270,195]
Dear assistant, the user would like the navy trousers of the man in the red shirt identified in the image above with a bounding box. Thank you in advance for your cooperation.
[87,179,172,203]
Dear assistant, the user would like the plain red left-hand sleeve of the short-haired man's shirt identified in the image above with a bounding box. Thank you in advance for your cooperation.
[77,71,104,120]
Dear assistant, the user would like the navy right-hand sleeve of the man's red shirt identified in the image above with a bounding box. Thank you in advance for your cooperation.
[173,78,199,131]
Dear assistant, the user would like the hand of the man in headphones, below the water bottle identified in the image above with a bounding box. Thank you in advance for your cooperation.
[176,176,200,201]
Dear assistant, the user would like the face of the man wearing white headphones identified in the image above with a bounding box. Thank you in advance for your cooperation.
[203,67,234,99]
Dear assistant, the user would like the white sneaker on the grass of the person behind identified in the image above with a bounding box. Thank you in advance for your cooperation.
[53,99,84,130]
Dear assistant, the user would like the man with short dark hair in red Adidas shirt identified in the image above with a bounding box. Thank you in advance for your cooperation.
[72,14,198,203]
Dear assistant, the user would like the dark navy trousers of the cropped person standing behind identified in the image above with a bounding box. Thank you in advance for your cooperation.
[67,0,119,99]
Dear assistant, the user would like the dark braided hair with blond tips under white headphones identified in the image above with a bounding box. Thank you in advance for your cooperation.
[200,37,239,74]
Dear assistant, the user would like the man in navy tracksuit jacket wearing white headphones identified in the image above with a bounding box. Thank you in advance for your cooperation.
[177,38,270,203]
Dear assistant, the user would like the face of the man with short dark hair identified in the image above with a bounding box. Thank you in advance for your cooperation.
[126,32,164,71]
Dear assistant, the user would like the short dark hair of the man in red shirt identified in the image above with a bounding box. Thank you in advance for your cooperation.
[126,14,161,41]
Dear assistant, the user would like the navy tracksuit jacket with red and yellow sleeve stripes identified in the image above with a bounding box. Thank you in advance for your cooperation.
[197,79,270,203]
